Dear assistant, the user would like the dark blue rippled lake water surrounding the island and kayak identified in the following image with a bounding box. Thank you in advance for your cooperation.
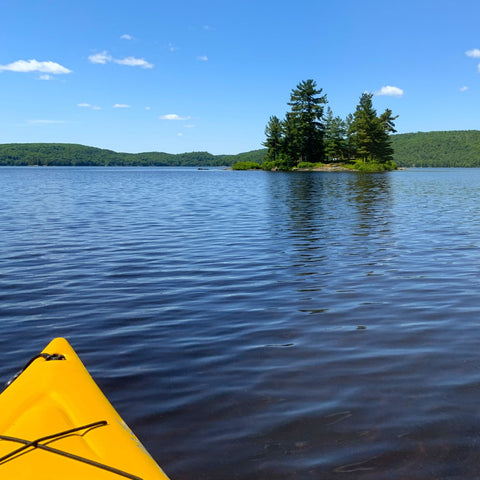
[0,167,480,480]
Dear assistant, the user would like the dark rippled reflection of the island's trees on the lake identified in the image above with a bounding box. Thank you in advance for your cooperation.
[262,172,395,328]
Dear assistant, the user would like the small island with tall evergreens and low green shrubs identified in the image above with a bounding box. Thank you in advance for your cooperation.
[232,79,397,172]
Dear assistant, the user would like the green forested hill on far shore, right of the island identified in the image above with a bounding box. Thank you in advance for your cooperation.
[392,130,480,167]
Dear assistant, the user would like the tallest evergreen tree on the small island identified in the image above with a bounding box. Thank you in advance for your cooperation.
[287,80,327,163]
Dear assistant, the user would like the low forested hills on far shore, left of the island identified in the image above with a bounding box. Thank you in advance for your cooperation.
[0,143,265,167]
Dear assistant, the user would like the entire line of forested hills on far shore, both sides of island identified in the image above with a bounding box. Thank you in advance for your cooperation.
[0,130,480,167]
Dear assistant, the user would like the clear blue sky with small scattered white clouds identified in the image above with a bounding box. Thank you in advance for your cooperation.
[0,0,480,154]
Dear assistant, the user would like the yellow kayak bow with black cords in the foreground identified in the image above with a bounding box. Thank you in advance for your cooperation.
[0,338,168,480]
